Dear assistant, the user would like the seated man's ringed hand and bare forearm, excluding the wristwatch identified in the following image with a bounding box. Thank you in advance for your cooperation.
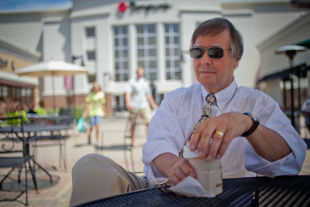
[190,112,291,162]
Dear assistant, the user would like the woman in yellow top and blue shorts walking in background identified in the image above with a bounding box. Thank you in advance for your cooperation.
[82,82,106,146]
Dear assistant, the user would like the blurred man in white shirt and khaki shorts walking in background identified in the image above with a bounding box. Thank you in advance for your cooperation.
[125,67,158,147]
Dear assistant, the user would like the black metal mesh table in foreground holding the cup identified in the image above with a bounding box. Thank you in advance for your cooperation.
[80,176,310,207]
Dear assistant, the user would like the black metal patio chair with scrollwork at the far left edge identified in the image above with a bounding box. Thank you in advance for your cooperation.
[0,117,37,206]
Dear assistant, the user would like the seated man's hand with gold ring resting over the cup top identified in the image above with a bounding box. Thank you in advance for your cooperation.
[190,112,253,161]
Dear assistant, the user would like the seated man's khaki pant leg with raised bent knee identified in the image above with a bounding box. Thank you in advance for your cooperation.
[70,154,151,206]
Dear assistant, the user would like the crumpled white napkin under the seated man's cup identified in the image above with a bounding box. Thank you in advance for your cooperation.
[165,176,215,198]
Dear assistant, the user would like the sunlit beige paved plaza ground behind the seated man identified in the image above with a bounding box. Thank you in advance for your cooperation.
[0,118,310,207]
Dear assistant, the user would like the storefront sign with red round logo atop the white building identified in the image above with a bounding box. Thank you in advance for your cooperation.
[118,1,170,13]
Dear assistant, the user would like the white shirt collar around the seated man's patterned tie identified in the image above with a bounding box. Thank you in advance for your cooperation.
[201,77,238,111]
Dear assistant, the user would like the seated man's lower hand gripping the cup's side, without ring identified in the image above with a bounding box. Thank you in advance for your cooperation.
[153,153,197,186]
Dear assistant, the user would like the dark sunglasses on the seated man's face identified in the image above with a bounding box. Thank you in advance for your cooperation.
[189,47,231,59]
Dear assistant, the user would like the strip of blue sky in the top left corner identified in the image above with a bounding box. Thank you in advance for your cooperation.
[0,0,72,11]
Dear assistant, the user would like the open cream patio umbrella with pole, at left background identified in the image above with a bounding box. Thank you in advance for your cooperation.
[15,60,88,111]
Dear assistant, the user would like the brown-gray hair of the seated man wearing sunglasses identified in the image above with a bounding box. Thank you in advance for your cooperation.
[191,18,243,59]
